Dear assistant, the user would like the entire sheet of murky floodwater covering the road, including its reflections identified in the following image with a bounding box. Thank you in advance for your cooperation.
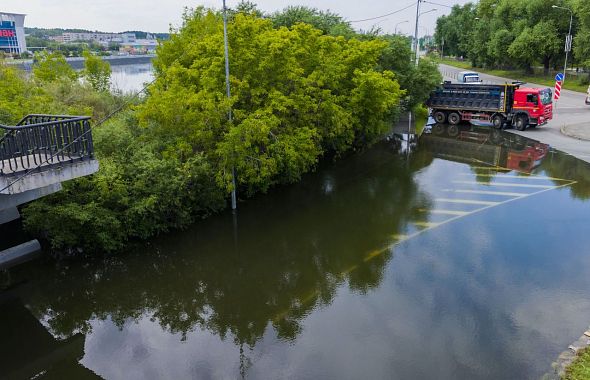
[0,125,590,379]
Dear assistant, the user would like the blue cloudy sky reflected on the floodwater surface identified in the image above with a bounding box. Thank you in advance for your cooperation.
[76,155,590,379]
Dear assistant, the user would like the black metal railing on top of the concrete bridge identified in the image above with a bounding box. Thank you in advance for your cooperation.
[0,115,94,176]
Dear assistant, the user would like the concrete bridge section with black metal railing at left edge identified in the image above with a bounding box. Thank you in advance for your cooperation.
[0,115,98,270]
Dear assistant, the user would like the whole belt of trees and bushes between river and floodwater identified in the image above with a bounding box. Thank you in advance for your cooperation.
[0,3,441,253]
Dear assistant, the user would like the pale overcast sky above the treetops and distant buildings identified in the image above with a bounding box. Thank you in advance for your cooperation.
[0,0,468,36]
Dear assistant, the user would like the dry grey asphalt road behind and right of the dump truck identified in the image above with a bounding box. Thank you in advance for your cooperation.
[439,64,590,162]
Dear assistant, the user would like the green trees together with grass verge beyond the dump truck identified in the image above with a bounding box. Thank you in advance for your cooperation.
[435,0,590,91]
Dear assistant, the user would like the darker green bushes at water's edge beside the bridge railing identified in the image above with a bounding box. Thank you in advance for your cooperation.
[23,114,224,252]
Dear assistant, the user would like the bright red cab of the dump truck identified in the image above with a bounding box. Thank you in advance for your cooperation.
[513,87,553,129]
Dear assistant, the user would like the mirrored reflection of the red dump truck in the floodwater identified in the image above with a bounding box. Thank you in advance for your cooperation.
[420,124,549,173]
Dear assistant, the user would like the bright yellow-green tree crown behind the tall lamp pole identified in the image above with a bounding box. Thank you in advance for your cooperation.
[140,8,403,194]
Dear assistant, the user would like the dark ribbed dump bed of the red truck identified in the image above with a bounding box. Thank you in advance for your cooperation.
[426,83,518,112]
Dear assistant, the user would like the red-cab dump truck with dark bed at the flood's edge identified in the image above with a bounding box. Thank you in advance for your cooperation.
[426,82,553,131]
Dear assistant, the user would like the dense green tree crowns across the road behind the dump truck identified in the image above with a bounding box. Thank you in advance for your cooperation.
[435,0,590,73]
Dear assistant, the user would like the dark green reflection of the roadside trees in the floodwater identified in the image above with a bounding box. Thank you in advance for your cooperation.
[12,140,431,346]
